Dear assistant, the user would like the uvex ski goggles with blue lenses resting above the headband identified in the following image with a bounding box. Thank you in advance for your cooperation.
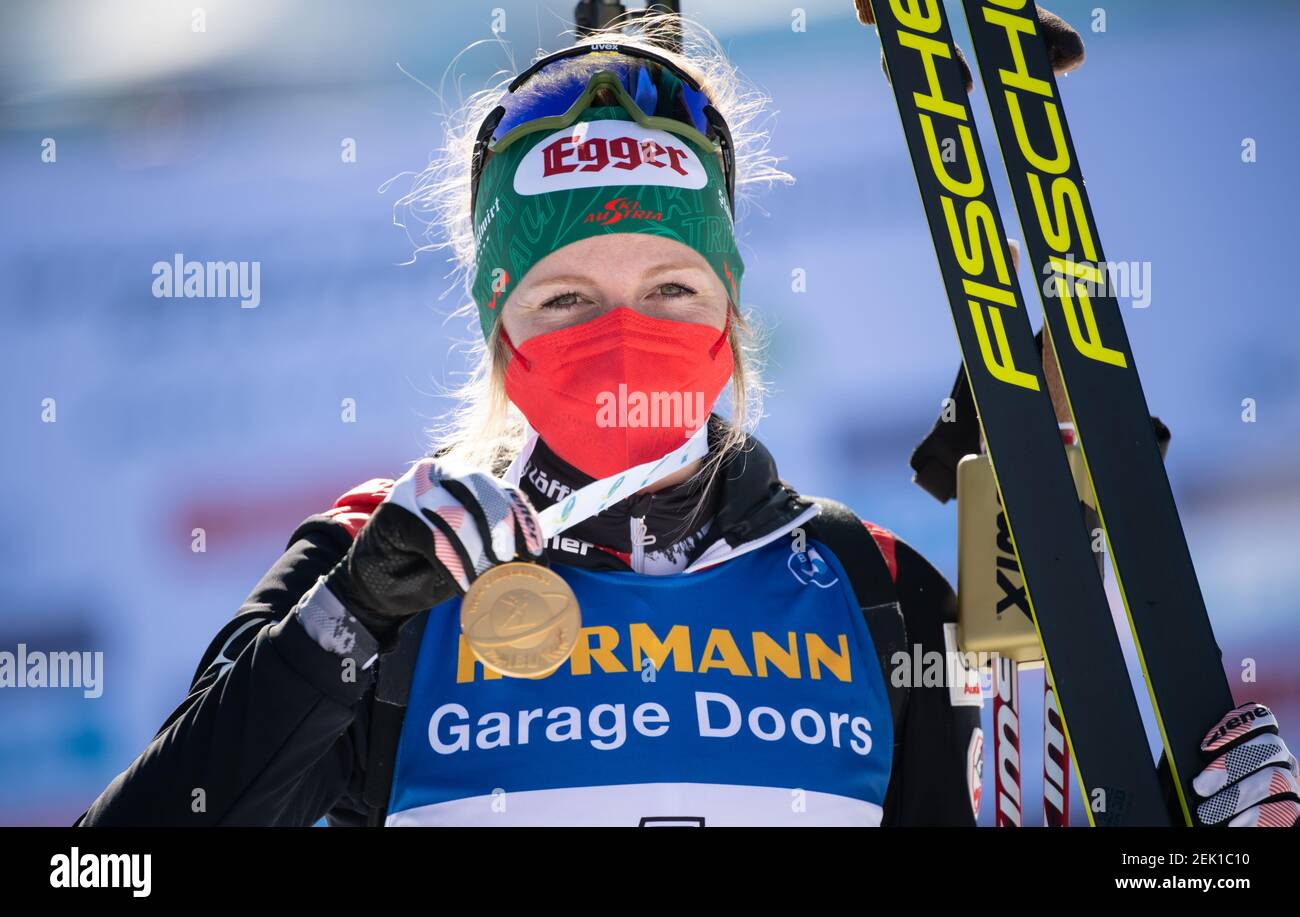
[469,43,736,217]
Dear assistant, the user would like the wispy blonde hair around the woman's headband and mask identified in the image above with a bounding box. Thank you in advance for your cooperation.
[394,16,794,479]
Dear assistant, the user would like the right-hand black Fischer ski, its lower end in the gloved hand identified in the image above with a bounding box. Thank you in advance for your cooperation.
[963,0,1234,825]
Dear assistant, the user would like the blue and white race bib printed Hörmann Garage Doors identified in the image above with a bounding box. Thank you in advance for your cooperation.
[387,538,893,826]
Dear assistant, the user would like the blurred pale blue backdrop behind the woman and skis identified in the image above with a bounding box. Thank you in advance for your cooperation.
[0,0,1300,823]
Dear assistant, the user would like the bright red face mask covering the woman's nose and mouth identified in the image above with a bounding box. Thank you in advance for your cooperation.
[502,306,733,477]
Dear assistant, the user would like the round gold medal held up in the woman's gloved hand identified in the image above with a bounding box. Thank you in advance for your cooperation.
[460,562,582,678]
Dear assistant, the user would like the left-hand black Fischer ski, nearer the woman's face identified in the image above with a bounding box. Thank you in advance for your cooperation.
[874,0,1170,825]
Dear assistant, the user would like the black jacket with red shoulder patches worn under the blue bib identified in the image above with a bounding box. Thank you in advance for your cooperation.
[77,426,979,826]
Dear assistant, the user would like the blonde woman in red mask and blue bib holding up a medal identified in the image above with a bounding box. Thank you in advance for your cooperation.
[81,16,1300,826]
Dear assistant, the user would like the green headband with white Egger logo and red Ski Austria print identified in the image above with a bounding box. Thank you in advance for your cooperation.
[471,107,745,337]
